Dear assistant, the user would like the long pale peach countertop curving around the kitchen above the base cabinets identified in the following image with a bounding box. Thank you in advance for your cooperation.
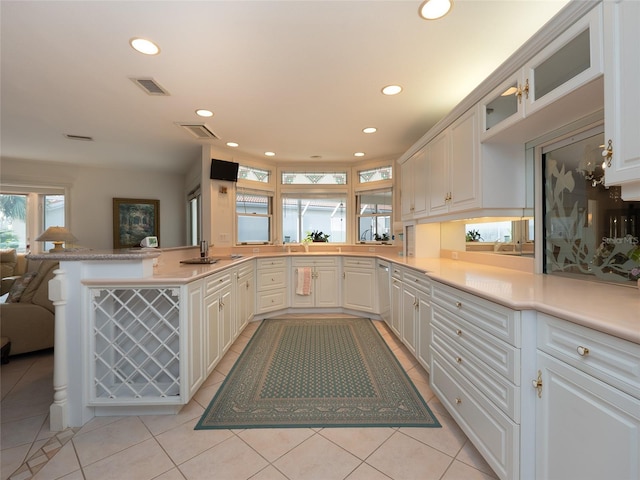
[46,251,640,344]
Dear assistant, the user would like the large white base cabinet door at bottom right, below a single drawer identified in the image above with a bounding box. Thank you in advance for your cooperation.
[535,351,640,480]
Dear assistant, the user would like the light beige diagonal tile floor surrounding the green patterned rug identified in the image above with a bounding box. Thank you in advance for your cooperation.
[0,322,496,480]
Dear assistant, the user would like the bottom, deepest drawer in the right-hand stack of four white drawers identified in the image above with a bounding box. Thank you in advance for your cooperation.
[430,350,520,479]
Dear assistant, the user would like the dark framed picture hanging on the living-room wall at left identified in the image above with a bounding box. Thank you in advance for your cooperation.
[113,198,160,249]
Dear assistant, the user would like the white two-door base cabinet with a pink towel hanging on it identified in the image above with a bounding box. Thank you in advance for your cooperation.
[291,256,340,308]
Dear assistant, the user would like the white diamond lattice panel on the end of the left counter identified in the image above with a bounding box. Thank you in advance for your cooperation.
[91,288,180,400]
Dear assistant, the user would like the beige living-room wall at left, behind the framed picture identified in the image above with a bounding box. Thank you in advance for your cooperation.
[0,158,186,250]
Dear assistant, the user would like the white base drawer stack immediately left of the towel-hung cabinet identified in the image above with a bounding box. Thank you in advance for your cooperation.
[256,257,289,313]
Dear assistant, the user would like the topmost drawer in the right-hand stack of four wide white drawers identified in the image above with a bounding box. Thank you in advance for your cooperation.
[431,284,521,347]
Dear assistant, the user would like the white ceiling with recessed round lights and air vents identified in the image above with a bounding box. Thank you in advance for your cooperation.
[0,0,567,172]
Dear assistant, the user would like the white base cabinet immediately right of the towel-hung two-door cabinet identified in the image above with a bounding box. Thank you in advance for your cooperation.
[342,257,378,313]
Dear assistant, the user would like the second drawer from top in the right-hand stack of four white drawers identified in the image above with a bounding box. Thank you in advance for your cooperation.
[432,304,520,385]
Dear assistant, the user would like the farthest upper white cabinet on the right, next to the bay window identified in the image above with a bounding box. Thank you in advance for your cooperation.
[400,148,428,220]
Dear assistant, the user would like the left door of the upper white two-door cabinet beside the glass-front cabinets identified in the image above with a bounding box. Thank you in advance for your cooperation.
[427,130,450,215]
